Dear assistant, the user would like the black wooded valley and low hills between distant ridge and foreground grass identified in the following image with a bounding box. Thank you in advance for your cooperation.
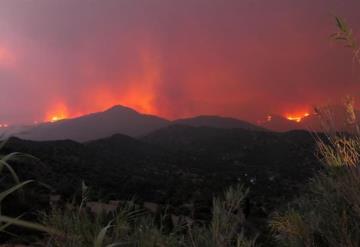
[3,125,320,241]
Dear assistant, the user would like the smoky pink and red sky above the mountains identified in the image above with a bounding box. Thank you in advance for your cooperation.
[0,0,360,123]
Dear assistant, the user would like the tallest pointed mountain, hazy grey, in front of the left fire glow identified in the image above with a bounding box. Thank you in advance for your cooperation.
[17,105,169,142]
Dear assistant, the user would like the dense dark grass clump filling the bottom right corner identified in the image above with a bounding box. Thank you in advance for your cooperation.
[271,167,360,247]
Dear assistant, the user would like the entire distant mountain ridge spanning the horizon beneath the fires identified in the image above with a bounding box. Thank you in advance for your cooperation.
[7,105,358,142]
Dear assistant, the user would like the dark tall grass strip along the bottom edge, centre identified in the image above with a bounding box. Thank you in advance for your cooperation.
[42,183,256,247]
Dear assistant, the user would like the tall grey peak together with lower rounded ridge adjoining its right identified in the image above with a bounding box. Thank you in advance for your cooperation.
[10,105,266,142]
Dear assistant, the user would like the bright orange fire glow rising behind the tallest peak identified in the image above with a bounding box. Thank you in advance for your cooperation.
[43,44,162,122]
